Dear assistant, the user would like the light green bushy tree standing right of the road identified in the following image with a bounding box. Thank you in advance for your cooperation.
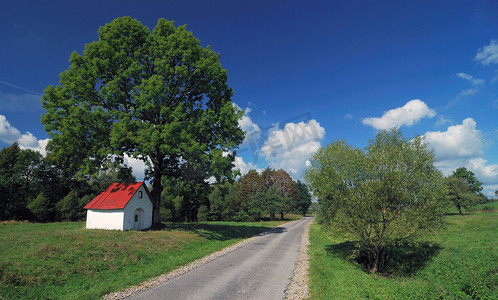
[306,129,445,272]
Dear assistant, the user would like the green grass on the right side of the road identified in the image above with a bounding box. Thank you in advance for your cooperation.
[309,207,498,299]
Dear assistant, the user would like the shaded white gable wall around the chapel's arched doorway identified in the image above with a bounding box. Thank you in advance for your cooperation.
[123,185,152,230]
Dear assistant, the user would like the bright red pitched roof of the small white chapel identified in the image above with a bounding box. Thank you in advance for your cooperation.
[83,181,149,209]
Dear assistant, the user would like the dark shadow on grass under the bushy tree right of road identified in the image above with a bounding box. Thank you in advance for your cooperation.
[325,241,441,277]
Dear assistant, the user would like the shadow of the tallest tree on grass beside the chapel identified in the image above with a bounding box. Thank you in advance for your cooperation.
[154,223,276,241]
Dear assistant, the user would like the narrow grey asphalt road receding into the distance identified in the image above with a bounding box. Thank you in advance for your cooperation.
[126,218,312,300]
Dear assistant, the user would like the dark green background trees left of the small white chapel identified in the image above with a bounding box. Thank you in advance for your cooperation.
[0,143,136,222]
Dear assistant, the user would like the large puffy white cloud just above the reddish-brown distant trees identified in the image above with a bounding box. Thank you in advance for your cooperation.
[261,120,325,179]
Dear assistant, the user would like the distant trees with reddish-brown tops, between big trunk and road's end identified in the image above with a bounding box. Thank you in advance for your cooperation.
[161,168,311,221]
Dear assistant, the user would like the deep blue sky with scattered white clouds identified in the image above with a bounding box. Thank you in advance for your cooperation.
[0,0,498,196]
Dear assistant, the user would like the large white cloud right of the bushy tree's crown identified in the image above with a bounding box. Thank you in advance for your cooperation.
[424,118,483,160]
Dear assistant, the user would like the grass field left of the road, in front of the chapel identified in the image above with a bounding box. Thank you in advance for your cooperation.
[0,221,292,299]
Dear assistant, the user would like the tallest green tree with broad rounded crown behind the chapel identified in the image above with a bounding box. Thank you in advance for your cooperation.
[42,17,244,223]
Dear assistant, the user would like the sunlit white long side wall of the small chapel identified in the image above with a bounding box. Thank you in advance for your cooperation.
[86,209,124,230]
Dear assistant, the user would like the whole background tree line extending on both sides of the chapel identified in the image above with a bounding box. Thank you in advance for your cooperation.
[0,143,311,222]
